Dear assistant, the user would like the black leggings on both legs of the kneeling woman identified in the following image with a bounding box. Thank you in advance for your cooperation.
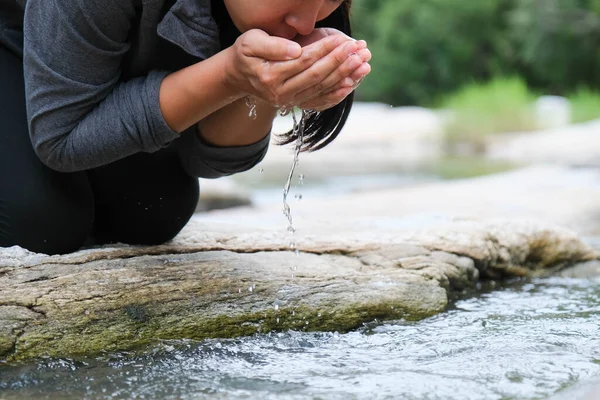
[0,45,199,255]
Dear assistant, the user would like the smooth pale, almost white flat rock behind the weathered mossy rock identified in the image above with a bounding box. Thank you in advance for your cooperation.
[207,165,600,236]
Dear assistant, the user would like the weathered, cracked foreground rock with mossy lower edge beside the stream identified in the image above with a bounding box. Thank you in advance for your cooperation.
[0,220,597,361]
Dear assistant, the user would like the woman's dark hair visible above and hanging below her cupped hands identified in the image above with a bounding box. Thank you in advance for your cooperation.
[279,0,354,151]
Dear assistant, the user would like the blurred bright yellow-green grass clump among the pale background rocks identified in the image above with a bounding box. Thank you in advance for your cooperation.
[441,78,537,151]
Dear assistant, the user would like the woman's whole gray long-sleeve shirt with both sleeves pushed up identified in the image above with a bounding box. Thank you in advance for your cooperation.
[0,0,269,178]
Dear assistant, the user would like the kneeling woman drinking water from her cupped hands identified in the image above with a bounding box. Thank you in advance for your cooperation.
[0,0,370,254]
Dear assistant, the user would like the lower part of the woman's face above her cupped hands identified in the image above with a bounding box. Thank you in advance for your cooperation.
[224,0,344,39]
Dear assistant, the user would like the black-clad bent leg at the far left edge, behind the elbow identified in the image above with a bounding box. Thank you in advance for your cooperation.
[0,45,94,254]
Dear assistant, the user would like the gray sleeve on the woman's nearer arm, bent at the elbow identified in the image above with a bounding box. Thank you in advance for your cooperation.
[23,0,179,172]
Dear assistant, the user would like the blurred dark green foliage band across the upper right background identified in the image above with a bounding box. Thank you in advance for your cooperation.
[352,0,600,105]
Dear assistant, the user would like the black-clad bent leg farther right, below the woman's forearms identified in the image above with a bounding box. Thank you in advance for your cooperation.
[88,149,199,245]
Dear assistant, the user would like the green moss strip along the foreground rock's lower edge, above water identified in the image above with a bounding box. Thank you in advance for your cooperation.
[7,296,445,362]
